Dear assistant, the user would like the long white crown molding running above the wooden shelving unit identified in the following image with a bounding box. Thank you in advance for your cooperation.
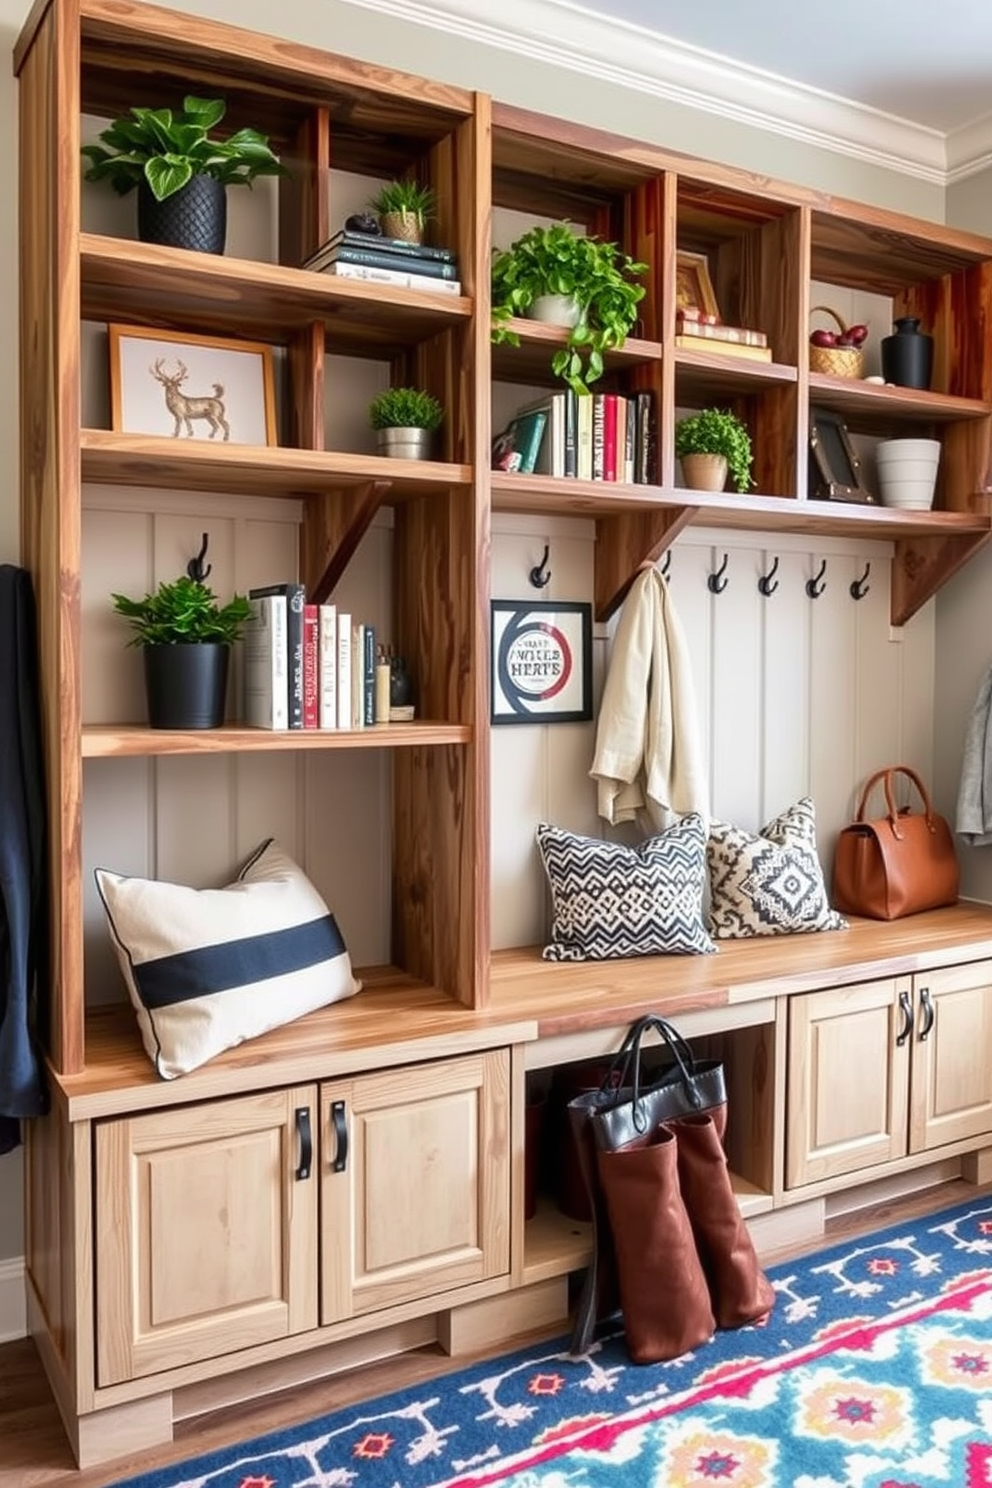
[348,0,947,186]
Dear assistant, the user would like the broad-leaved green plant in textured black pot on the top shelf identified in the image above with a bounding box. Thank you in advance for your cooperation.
[82,97,289,253]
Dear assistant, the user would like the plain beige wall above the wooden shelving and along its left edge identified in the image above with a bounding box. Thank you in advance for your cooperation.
[0,0,944,1262]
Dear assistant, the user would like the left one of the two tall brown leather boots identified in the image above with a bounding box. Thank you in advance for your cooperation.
[596,1126,715,1364]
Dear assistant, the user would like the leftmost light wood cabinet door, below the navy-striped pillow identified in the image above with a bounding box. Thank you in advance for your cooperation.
[95,1085,317,1385]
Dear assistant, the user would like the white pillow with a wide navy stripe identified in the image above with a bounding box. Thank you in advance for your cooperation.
[95,841,361,1080]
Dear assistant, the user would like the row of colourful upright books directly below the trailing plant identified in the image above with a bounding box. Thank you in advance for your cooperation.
[492,388,657,485]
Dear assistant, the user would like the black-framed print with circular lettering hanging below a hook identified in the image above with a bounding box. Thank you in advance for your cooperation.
[489,600,592,725]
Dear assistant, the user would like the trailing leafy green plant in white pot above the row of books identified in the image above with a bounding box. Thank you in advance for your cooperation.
[492,222,647,396]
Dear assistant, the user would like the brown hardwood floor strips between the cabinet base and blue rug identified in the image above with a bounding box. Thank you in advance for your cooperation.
[0,1181,989,1488]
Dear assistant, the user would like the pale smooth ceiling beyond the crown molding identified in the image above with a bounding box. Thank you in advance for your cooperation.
[576,0,992,134]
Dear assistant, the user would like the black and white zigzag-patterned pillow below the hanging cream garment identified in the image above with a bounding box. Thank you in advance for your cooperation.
[537,812,717,961]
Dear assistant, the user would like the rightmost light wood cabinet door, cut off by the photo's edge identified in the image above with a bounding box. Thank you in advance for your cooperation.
[910,961,992,1152]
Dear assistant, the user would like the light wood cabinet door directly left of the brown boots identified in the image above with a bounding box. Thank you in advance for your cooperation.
[320,1049,510,1323]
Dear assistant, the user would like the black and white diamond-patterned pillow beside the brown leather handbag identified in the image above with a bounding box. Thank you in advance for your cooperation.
[706,796,848,940]
